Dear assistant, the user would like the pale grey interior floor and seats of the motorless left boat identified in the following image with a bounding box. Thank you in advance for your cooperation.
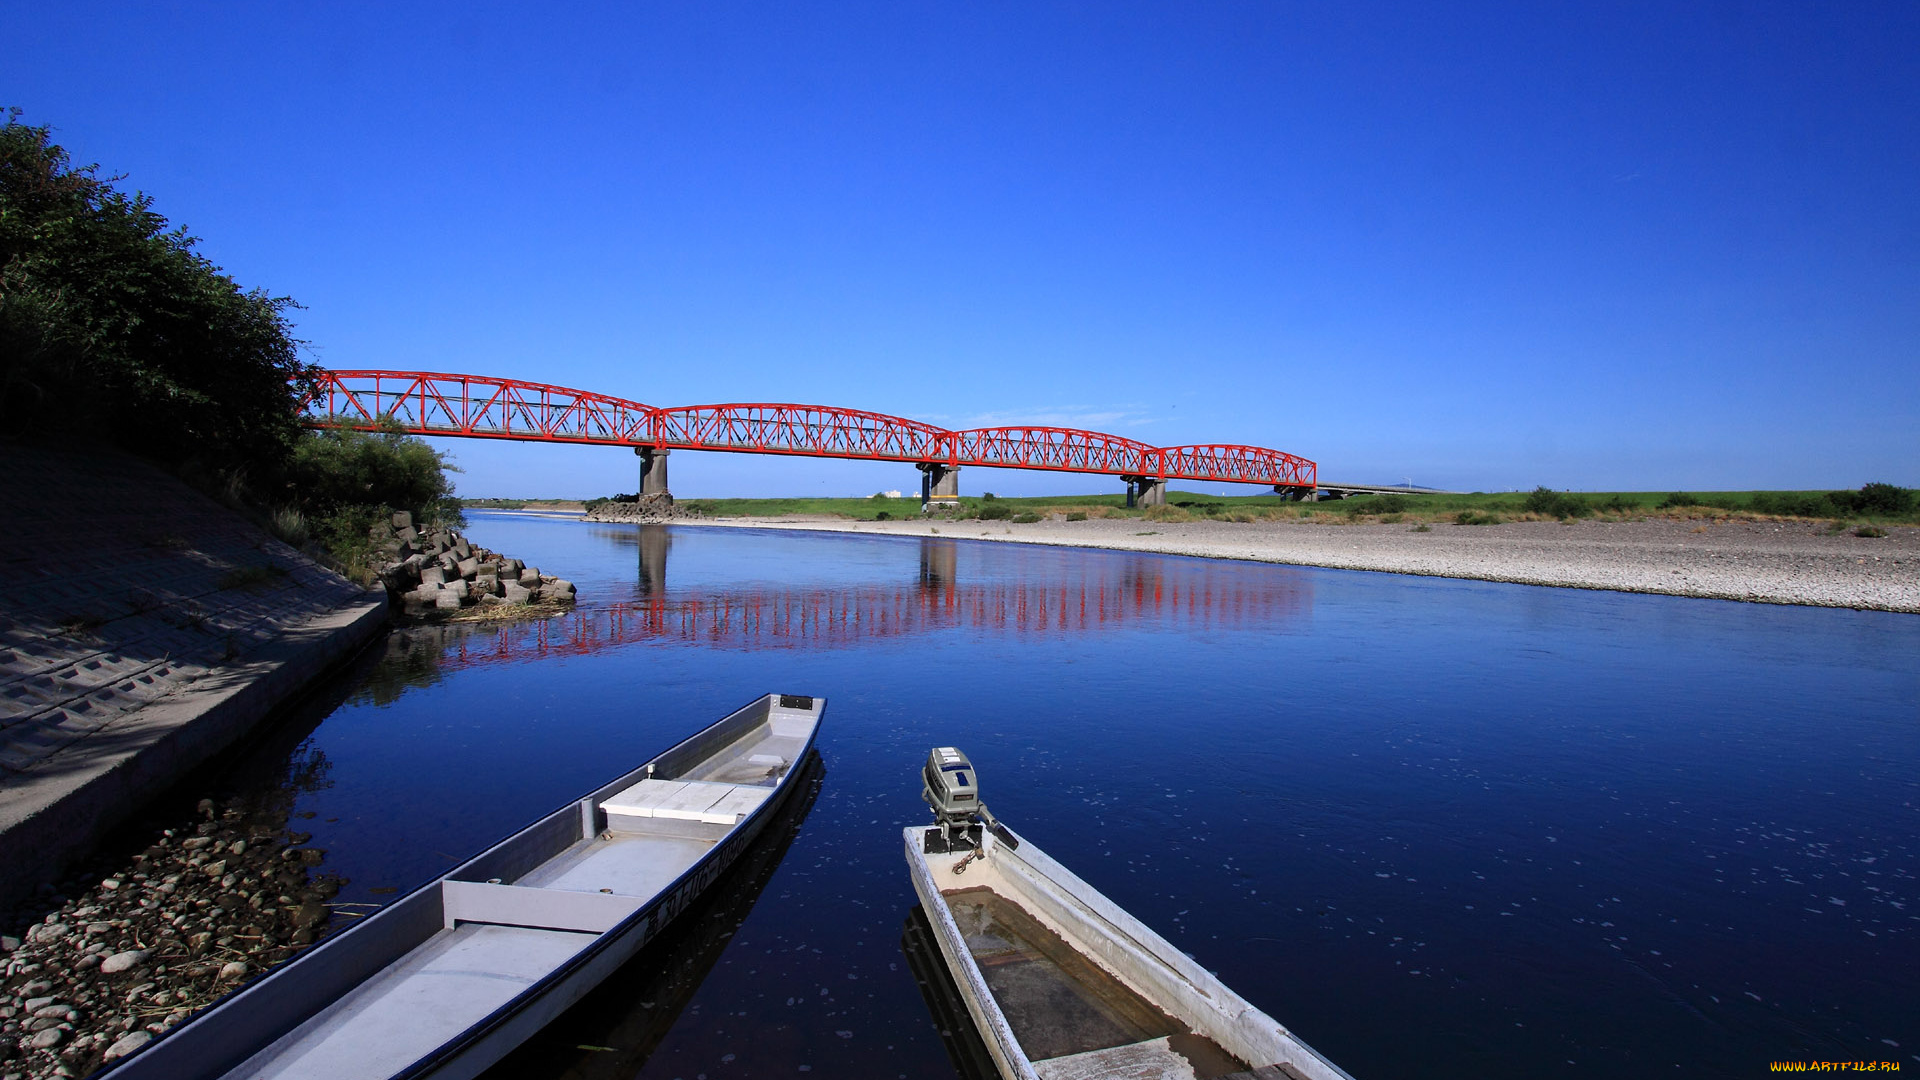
[202,696,818,1080]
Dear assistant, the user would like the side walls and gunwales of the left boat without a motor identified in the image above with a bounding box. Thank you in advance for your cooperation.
[96,694,826,1080]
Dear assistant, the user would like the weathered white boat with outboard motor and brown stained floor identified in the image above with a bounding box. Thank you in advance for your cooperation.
[904,748,1352,1080]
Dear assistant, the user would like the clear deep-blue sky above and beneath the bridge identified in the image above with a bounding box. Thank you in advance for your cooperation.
[0,0,1920,498]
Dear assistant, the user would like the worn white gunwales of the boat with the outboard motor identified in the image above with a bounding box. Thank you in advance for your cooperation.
[902,824,1354,1080]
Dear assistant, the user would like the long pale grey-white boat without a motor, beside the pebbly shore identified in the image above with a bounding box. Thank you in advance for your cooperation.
[108,694,826,1080]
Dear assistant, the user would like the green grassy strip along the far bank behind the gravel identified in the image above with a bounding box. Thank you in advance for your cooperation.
[549,484,1920,525]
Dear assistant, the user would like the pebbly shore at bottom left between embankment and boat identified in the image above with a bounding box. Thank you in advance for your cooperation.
[0,799,342,1080]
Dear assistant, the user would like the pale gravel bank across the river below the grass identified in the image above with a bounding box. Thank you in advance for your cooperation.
[685,517,1920,611]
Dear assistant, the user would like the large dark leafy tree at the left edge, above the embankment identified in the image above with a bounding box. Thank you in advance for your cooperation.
[0,110,313,484]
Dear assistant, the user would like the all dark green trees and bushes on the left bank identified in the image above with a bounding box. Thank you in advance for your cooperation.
[0,110,459,571]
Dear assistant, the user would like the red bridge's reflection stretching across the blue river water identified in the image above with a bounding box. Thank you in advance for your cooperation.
[428,542,1313,671]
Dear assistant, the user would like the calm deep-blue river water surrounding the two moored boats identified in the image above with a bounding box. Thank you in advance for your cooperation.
[232,513,1920,1080]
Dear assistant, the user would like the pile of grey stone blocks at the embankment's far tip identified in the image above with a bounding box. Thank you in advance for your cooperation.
[371,511,576,617]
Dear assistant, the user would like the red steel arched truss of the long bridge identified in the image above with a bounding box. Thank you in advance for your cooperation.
[303,371,1319,490]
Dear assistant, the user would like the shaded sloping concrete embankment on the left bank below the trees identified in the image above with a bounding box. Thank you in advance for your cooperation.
[0,448,388,903]
